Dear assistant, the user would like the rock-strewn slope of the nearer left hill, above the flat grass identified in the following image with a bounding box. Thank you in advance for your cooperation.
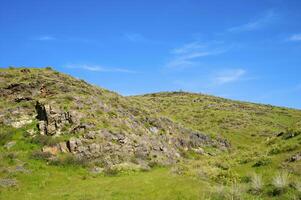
[0,69,230,170]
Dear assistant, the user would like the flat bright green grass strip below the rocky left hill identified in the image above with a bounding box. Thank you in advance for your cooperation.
[0,166,207,200]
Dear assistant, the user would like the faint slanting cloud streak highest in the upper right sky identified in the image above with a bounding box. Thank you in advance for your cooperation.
[228,10,278,32]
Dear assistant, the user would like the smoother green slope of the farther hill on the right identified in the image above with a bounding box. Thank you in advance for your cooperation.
[129,92,301,199]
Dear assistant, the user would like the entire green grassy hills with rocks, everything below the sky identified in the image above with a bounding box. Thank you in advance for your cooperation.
[0,68,301,199]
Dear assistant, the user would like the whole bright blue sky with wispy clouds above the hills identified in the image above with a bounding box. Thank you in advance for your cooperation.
[0,0,301,108]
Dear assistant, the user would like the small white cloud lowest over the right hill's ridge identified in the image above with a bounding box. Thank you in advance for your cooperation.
[213,69,246,85]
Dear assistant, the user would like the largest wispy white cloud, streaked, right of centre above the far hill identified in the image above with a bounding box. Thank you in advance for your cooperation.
[165,41,227,69]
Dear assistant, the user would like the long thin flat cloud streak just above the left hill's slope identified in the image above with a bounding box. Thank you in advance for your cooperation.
[65,64,137,74]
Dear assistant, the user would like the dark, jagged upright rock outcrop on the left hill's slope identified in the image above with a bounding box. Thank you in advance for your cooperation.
[35,101,73,135]
